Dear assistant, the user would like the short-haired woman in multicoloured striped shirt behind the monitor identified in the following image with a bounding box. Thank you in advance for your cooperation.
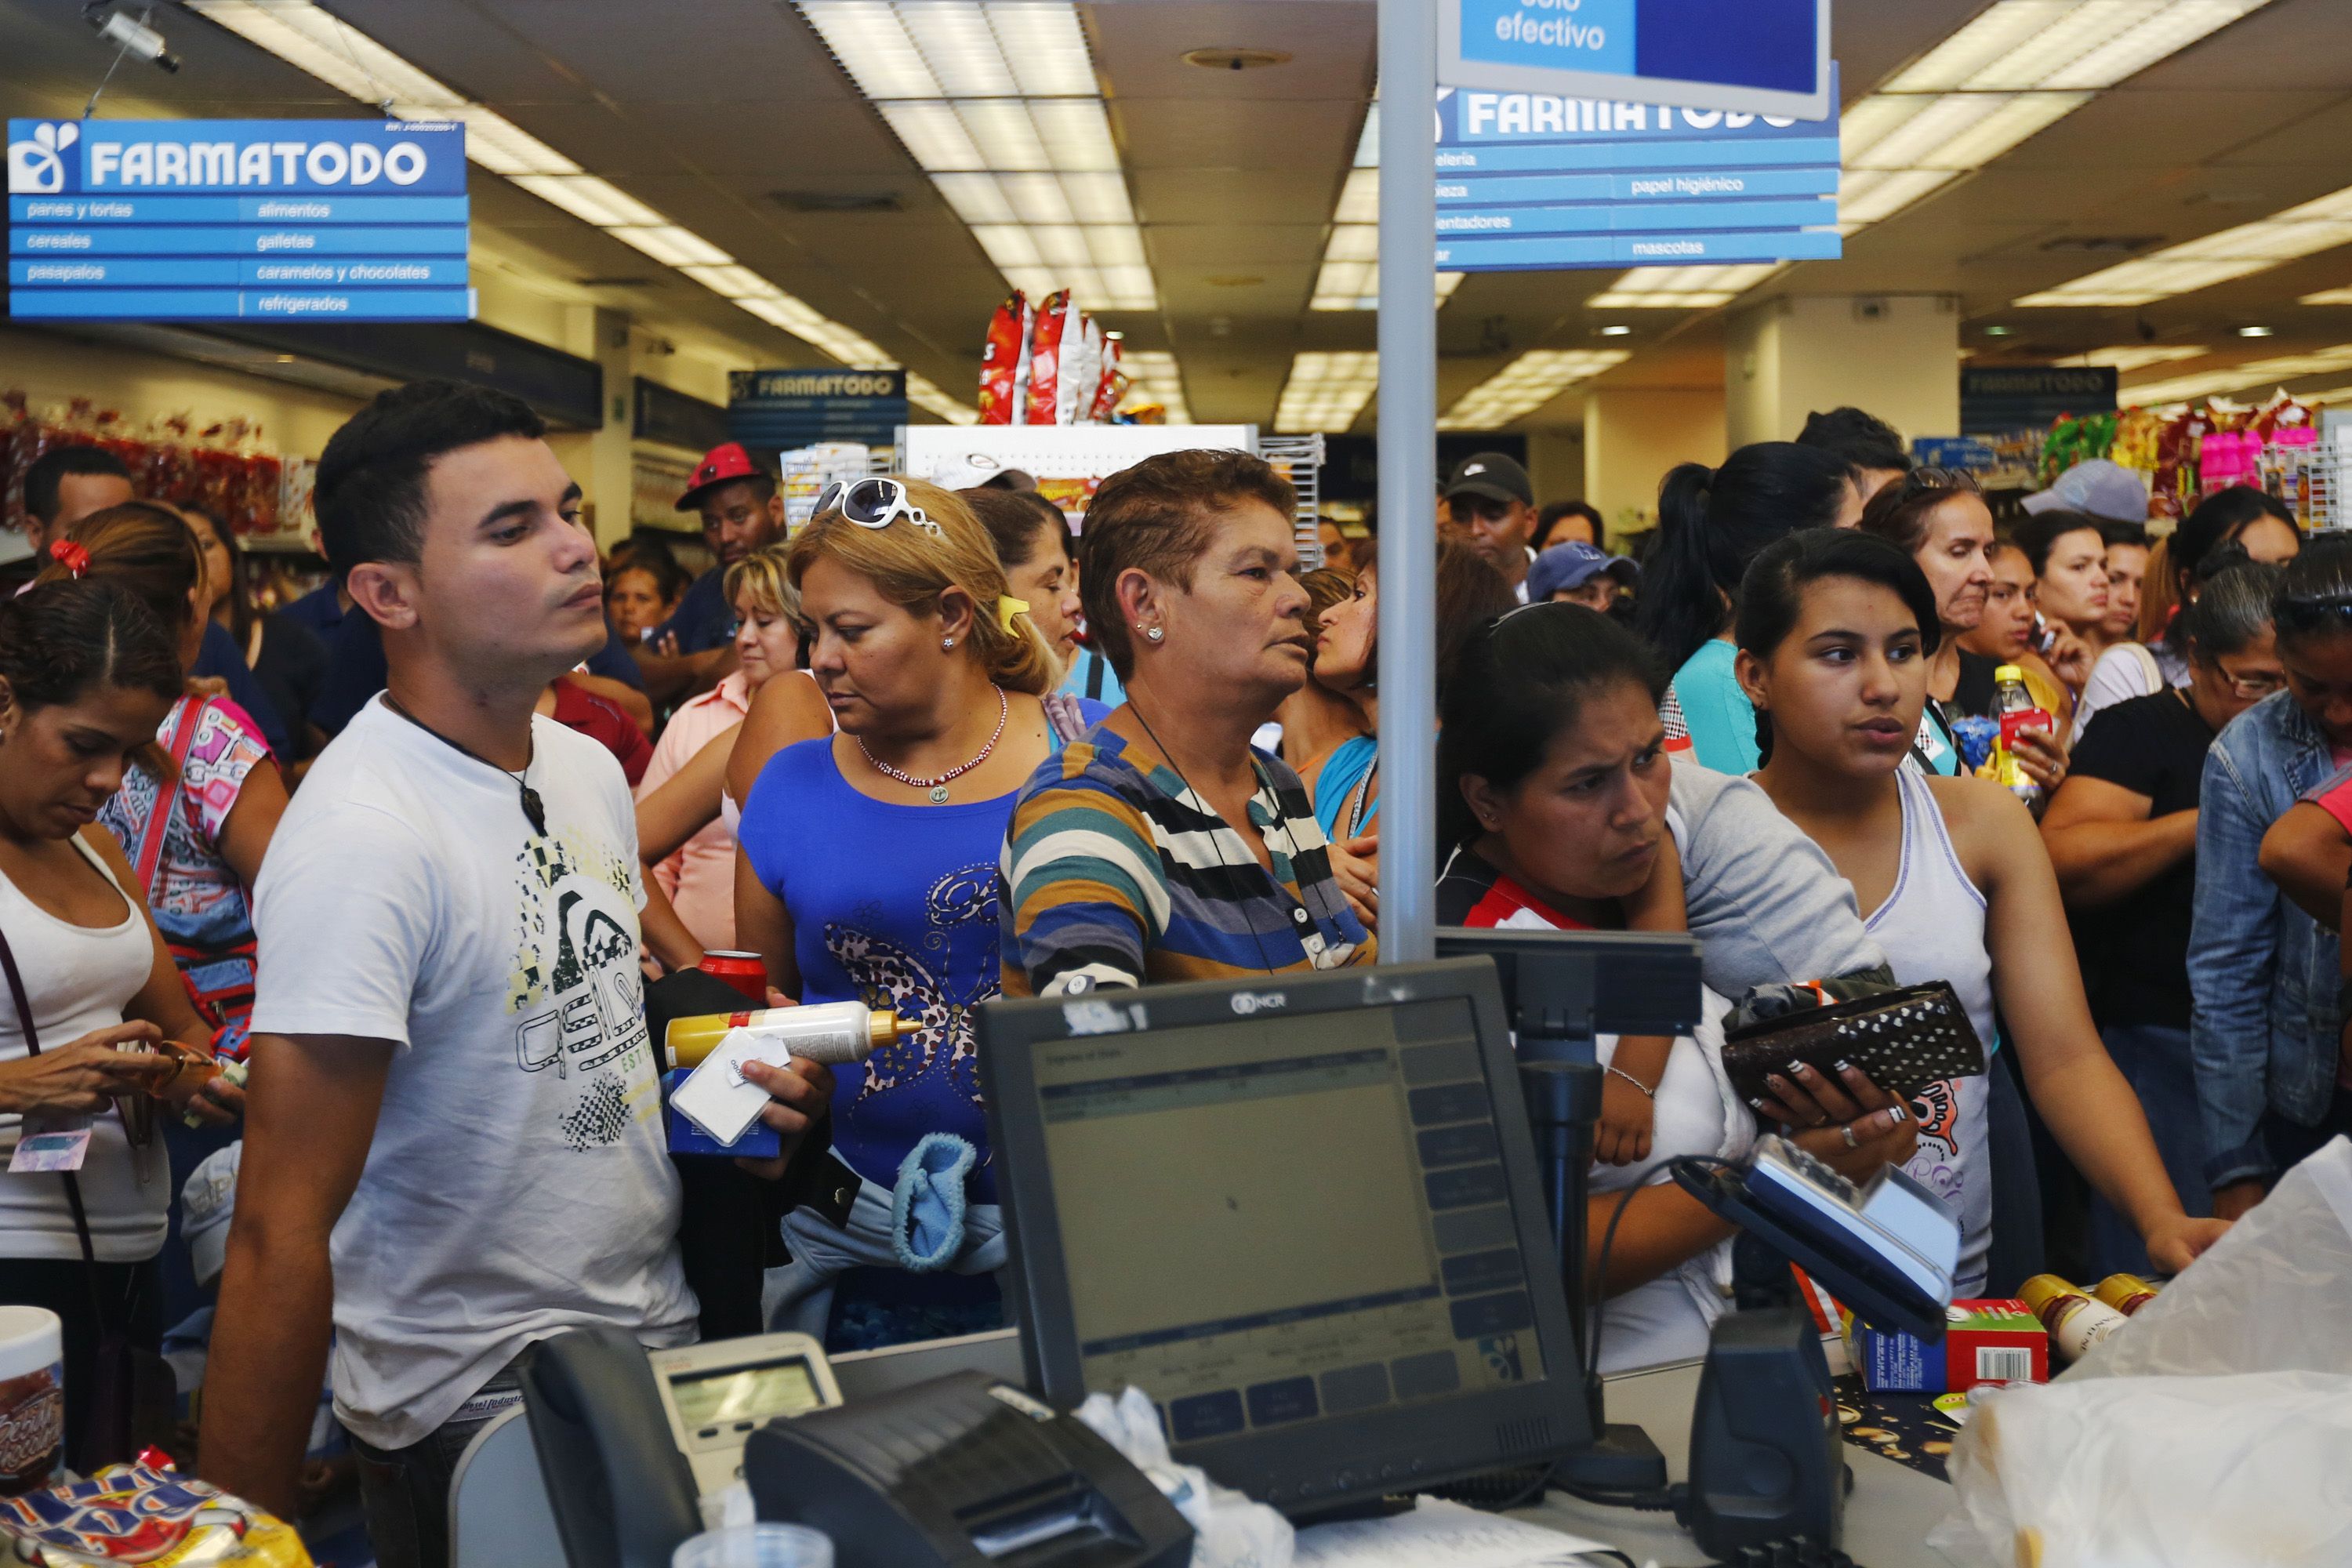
[1000,452,1374,996]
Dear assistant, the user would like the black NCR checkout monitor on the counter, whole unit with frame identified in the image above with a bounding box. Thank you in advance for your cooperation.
[978,961,1590,1514]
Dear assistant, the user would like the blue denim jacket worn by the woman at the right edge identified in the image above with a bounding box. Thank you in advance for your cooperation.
[2190,691,2340,1187]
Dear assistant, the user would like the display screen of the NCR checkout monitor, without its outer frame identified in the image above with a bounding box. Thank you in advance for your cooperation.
[1037,999,1545,1443]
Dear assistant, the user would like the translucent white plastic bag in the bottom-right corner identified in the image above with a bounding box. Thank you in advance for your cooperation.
[1929,1138,2352,1568]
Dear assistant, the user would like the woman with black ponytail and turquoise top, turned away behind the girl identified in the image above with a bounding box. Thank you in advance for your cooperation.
[1635,442,1849,776]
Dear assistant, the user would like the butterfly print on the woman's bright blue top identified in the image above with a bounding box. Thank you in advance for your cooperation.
[826,865,997,1109]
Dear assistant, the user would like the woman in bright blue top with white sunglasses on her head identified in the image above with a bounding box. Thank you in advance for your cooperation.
[736,480,1098,1349]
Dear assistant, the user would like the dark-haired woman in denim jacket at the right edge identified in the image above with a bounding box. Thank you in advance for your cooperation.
[2190,534,2352,1218]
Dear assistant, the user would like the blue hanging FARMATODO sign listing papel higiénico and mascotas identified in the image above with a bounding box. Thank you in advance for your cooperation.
[1437,68,1844,273]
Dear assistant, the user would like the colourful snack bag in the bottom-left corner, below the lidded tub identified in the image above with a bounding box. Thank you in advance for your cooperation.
[0,1462,310,1568]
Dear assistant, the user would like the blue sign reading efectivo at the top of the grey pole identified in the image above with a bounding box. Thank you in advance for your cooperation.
[1437,0,1832,120]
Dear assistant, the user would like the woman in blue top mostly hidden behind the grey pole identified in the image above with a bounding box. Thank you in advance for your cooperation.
[1308,539,1519,865]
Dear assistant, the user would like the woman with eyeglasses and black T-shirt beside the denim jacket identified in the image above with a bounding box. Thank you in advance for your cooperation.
[2042,562,2286,1274]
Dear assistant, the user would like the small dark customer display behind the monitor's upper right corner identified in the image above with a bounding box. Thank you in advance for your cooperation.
[1437,926,1700,1060]
